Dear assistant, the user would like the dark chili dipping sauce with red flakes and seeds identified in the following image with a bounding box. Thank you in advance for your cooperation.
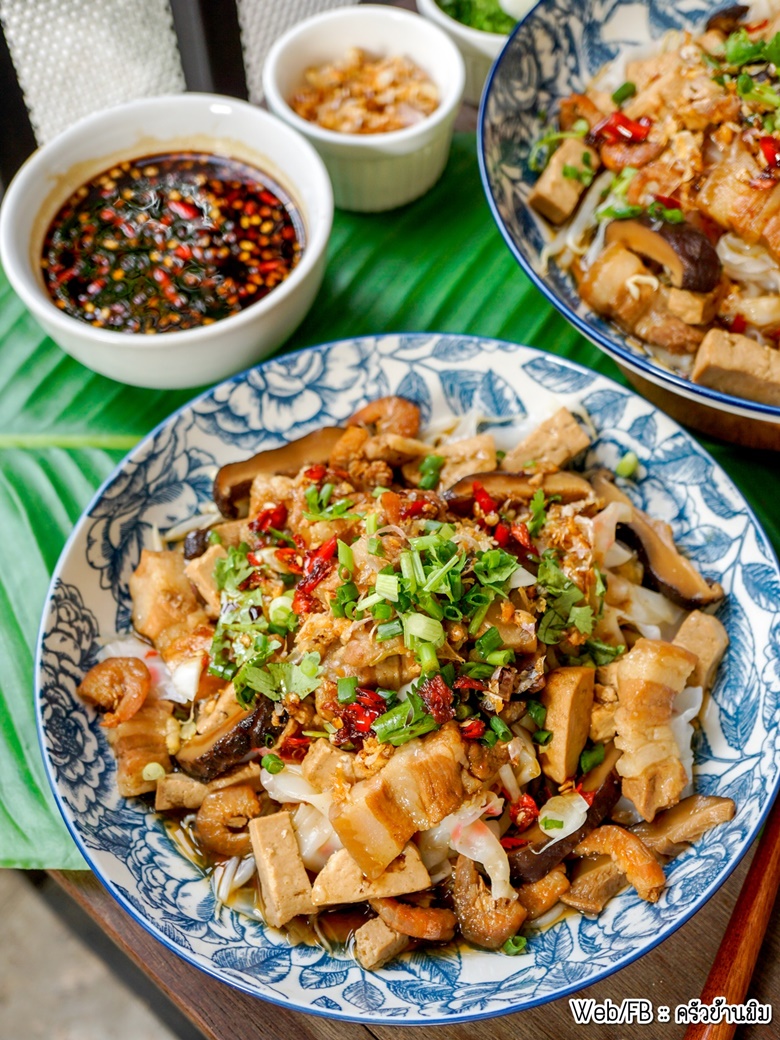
[41,152,304,333]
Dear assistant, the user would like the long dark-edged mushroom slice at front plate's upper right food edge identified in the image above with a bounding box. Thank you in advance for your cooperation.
[591,470,724,610]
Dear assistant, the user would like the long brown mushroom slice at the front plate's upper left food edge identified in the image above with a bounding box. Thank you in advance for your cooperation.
[214,426,343,519]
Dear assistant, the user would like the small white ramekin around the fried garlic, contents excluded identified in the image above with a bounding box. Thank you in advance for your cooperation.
[263,4,465,212]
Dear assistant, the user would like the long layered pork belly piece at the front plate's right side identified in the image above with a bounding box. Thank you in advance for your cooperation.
[615,639,697,821]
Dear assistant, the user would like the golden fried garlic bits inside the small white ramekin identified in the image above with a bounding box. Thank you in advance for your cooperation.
[289,48,439,134]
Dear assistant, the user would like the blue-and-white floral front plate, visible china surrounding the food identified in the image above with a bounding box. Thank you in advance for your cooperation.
[36,334,780,1023]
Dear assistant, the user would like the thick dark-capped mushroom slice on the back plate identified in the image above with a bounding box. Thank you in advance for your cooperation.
[605,216,722,292]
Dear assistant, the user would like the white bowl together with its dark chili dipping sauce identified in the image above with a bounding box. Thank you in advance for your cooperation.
[0,94,333,389]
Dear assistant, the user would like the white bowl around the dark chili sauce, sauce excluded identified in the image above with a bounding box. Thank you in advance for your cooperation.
[0,94,333,389]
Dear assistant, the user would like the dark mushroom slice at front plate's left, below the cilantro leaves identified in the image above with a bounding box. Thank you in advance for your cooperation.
[176,697,287,783]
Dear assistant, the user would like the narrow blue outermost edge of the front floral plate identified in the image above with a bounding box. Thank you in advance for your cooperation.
[33,331,780,1026]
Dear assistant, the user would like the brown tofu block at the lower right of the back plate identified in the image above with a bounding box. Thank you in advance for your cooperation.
[691,328,780,405]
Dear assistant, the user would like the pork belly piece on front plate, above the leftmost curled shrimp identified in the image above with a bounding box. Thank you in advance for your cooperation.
[130,549,207,644]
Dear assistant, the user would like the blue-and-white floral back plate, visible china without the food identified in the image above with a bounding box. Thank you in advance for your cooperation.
[477,0,780,423]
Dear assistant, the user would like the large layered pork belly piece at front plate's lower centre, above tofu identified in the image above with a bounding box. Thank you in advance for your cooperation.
[332,722,467,879]
